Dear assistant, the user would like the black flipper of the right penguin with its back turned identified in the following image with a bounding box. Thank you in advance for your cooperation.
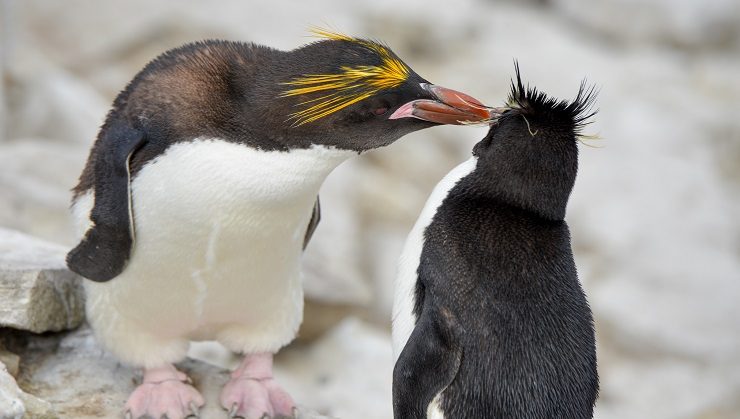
[393,304,462,419]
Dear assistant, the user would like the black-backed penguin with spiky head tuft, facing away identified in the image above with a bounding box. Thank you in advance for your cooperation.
[392,65,599,419]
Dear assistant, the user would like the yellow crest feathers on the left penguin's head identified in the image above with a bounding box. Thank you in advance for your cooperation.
[280,28,411,126]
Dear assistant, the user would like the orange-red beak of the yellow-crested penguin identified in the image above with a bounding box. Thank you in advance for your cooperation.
[388,83,502,125]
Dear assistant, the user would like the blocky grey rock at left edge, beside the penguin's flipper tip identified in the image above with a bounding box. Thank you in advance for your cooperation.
[0,229,84,333]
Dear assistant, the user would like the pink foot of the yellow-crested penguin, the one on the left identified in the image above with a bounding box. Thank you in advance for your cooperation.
[125,365,205,419]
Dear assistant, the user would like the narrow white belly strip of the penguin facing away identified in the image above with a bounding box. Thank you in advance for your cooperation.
[393,157,478,360]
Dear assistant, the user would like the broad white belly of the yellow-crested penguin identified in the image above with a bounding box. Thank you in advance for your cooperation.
[75,139,352,368]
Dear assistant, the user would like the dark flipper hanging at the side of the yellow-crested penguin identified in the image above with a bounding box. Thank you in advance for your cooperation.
[67,119,146,282]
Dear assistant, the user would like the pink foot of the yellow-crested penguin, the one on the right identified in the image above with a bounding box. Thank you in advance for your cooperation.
[221,354,296,419]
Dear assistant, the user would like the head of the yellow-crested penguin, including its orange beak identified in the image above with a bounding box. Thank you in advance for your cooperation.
[251,31,490,151]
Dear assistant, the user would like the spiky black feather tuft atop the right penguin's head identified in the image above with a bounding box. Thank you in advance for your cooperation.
[508,60,598,135]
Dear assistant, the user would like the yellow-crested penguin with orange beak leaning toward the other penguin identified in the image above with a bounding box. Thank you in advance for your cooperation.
[66,29,498,419]
